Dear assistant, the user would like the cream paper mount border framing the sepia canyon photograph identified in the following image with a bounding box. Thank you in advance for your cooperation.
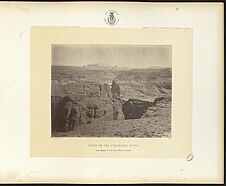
[30,27,192,158]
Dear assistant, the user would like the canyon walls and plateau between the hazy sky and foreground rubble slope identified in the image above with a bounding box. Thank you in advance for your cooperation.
[51,67,172,135]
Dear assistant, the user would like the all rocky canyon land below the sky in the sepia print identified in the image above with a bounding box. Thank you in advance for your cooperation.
[51,66,172,137]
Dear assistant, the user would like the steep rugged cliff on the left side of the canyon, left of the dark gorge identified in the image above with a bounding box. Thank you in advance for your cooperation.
[51,82,125,132]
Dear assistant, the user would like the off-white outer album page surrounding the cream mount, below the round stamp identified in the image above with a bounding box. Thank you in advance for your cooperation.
[0,3,224,183]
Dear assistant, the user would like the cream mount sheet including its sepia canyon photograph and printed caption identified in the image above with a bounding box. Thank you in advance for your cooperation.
[30,27,192,157]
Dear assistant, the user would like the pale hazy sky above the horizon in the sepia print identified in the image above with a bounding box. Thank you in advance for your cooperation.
[52,45,172,68]
